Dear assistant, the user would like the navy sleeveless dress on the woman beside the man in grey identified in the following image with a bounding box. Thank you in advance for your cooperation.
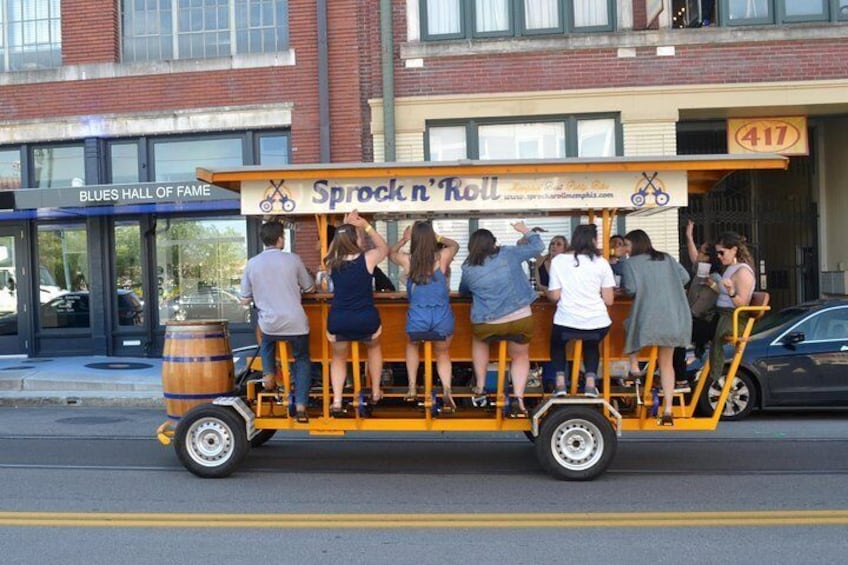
[327,253,380,339]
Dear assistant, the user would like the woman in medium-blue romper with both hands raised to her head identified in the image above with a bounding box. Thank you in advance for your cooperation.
[390,221,459,412]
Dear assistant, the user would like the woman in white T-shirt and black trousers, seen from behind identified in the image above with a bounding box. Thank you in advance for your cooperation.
[548,224,615,397]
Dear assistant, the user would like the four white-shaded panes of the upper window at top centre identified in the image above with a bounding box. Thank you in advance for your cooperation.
[419,0,615,40]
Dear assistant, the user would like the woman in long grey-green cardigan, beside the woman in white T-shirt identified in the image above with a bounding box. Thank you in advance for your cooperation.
[622,230,692,425]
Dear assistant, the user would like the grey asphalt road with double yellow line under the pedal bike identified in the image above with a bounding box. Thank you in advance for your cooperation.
[0,407,848,565]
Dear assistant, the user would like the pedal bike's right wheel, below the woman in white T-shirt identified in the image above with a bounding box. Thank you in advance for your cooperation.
[536,406,616,481]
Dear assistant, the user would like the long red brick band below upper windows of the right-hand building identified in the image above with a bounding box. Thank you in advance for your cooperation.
[396,40,848,96]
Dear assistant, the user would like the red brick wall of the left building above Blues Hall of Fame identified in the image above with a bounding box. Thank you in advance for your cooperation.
[0,0,380,170]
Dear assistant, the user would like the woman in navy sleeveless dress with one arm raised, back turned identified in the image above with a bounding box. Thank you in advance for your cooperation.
[324,210,389,416]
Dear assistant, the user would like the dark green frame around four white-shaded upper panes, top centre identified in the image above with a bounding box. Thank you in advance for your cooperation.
[418,0,612,42]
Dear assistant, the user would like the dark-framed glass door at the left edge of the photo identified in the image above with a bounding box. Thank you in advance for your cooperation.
[0,224,31,355]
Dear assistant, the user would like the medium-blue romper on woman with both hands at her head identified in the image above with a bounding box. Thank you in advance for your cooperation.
[406,268,455,337]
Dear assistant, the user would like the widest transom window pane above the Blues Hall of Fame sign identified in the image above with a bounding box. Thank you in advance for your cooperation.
[153,136,245,181]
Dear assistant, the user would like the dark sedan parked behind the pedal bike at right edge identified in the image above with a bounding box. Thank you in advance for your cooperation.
[700,300,848,420]
